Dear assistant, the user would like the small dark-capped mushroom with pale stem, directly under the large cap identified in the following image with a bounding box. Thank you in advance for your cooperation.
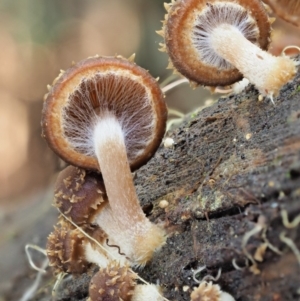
[54,165,146,264]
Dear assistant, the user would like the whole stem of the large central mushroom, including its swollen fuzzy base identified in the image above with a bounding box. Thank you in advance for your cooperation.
[94,114,165,265]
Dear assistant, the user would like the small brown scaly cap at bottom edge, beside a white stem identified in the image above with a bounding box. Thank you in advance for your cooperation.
[89,261,136,301]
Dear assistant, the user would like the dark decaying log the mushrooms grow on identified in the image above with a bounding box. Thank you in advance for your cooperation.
[31,62,300,301]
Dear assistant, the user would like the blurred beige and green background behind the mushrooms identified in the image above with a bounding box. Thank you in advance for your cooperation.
[0,0,300,301]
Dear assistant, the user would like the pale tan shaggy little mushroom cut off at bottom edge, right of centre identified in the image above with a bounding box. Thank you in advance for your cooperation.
[191,281,235,301]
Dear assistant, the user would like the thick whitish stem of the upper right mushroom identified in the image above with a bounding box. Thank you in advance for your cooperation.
[210,24,296,99]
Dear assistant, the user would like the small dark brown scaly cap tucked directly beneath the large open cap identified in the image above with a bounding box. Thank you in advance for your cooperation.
[54,165,107,226]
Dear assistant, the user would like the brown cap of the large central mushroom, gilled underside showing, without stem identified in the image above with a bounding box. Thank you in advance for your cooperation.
[42,56,167,171]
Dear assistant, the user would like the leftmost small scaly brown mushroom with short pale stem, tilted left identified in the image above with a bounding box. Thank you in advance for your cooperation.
[46,222,127,274]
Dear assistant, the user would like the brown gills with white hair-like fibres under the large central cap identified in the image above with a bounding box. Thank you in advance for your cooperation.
[62,71,156,162]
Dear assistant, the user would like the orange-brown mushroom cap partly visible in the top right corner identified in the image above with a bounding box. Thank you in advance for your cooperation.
[264,0,300,27]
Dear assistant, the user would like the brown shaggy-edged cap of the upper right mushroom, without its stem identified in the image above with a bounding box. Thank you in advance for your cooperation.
[163,0,270,86]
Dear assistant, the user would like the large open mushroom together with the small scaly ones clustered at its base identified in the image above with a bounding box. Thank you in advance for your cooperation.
[42,56,167,301]
